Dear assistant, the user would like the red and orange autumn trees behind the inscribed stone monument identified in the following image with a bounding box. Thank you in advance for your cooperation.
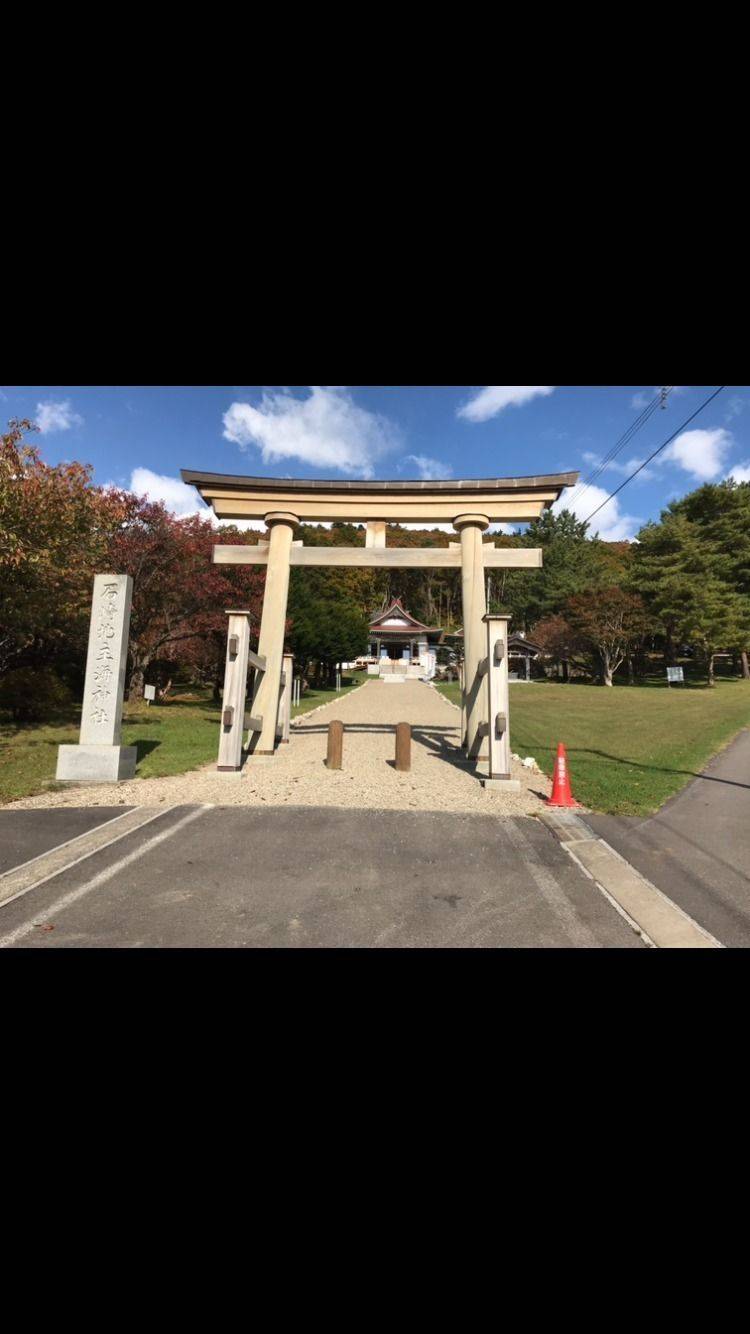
[0,420,264,699]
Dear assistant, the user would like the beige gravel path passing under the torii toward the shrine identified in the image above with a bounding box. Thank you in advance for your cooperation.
[5,680,550,815]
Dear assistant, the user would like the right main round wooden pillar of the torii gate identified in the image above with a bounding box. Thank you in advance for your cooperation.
[454,514,490,759]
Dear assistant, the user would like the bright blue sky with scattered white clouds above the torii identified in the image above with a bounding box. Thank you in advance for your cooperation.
[0,386,750,540]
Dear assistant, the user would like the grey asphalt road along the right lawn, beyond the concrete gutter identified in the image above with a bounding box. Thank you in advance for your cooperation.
[586,731,750,946]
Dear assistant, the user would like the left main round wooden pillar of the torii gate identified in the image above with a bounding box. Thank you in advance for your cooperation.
[250,511,298,755]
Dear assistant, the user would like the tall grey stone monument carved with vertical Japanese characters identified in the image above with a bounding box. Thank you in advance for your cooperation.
[56,575,137,783]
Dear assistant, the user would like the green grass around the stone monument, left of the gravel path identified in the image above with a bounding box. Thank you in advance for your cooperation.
[0,672,367,804]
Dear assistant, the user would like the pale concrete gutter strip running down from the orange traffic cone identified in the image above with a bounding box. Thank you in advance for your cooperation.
[538,808,723,950]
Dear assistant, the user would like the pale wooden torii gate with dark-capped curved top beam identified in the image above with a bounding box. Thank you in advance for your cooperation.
[181,468,578,768]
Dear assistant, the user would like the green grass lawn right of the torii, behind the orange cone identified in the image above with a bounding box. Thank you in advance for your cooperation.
[438,680,750,815]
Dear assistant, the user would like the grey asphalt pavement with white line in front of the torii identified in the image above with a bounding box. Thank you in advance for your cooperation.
[0,806,645,950]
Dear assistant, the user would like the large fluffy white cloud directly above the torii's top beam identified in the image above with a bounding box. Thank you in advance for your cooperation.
[224,384,400,478]
